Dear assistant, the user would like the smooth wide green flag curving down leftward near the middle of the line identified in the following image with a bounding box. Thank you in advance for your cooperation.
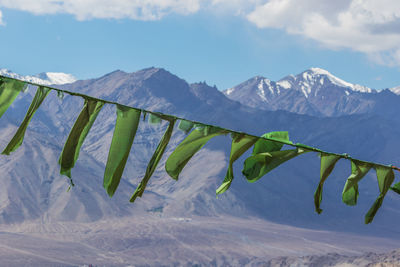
[165,126,228,180]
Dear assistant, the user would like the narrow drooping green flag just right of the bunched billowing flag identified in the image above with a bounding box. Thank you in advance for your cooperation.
[314,153,340,214]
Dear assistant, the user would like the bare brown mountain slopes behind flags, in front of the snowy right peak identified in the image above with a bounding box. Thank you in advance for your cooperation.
[0,68,400,265]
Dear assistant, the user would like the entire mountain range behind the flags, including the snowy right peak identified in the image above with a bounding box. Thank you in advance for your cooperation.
[0,68,400,266]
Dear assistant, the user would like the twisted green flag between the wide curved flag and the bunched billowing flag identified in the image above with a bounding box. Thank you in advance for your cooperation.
[216,134,258,195]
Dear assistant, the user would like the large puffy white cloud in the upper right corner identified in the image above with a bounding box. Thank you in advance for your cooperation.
[247,0,400,65]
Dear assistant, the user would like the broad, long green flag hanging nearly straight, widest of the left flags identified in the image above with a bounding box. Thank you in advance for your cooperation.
[103,105,140,197]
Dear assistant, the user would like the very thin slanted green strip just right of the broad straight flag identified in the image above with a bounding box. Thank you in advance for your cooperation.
[130,116,175,202]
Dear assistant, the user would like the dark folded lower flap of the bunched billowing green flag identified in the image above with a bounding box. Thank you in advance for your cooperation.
[242,148,308,183]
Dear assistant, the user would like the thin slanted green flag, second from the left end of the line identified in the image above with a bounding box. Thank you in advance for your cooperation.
[1,86,51,155]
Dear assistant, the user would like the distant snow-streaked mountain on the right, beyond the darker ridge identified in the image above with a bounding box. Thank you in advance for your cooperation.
[224,68,400,120]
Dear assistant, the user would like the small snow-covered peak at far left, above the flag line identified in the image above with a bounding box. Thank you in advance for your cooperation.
[0,69,76,85]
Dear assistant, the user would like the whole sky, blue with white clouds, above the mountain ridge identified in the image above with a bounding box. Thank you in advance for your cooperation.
[0,0,400,89]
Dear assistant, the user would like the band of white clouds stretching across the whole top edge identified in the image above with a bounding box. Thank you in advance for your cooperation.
[0,0,400,65]
